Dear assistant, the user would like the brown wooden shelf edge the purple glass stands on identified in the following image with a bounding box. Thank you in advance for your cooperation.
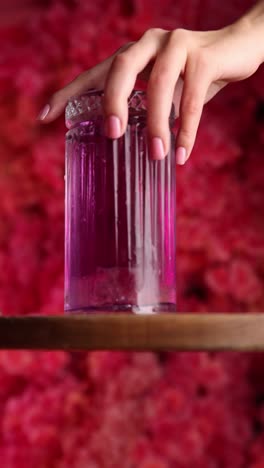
[0,313,264,351]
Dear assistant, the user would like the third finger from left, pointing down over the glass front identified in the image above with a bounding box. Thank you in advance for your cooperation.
[147,33,185,159]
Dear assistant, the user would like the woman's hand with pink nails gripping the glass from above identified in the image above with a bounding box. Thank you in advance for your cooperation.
[39,7,264,164]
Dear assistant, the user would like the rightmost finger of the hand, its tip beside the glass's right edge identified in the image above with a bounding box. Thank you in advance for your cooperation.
[176,54,211,164]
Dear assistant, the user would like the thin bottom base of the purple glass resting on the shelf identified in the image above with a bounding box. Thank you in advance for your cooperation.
[65,302,176,315]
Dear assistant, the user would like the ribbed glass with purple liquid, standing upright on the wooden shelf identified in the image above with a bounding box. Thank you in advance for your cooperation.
[65,91,176,313]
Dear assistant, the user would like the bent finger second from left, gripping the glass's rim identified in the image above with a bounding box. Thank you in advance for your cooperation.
[104,30,162,138]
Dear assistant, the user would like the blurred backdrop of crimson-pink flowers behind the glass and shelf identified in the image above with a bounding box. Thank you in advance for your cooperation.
[0,0,264,468]
